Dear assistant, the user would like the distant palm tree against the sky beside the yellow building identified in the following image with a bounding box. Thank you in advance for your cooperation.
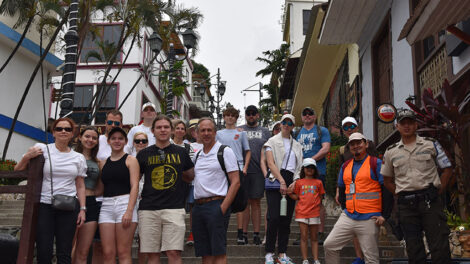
[256,43,289,117]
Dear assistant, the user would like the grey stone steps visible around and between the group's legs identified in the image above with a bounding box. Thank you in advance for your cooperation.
[0,199,404,264]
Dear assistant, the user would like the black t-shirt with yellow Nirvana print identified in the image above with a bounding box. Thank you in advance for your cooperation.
[137,144,194,210]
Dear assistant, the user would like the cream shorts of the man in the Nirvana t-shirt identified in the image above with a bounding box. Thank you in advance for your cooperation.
[139,209,186,253]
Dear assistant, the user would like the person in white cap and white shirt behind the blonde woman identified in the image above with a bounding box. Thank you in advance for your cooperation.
[127,102,157,156]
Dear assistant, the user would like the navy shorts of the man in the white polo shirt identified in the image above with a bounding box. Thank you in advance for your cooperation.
[192,200,230,257]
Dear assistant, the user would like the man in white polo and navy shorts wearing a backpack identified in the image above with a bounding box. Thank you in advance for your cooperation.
[192,117,240,264]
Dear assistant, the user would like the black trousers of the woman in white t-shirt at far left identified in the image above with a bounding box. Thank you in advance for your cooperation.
[36,203,78,264]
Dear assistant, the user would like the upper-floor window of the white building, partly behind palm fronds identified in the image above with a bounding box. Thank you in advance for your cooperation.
[80,24,122,63]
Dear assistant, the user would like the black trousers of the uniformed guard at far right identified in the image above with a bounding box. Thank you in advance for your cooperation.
[398,197,451,264]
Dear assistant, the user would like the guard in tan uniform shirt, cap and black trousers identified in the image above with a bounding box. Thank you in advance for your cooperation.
[380,109,452,264]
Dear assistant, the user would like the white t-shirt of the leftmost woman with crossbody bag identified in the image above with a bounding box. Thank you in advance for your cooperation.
[34,143,87,204]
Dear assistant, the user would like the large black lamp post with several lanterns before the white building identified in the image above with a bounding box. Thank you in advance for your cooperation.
[148,28,197,115]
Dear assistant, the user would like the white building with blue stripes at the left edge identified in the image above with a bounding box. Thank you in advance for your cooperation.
[0,12,63,161]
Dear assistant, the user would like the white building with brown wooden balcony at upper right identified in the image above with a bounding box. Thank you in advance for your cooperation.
[319,0,470,150]
